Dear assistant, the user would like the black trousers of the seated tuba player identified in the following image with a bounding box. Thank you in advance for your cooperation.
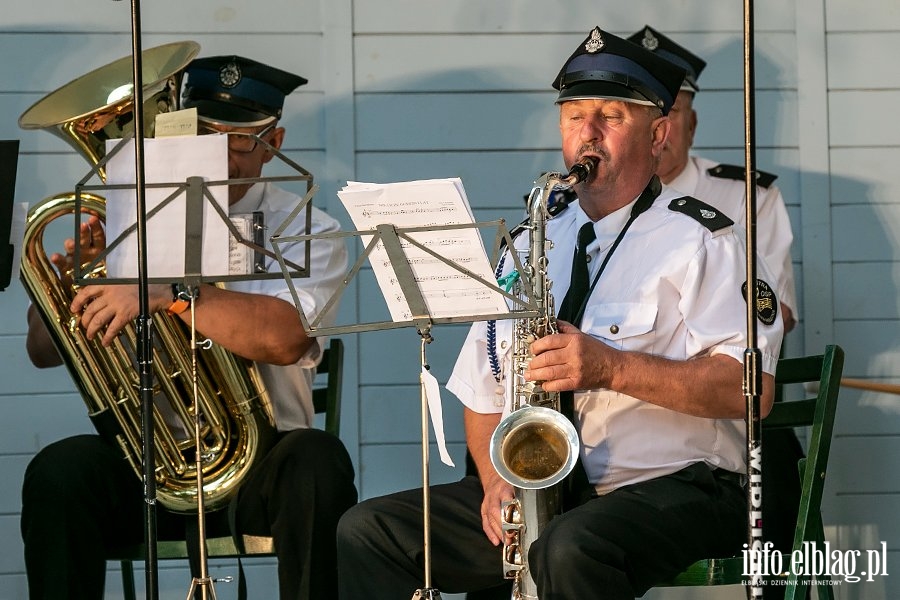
[21,429,357,600]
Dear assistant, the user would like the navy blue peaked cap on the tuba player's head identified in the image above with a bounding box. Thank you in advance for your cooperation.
[181,56,306,127]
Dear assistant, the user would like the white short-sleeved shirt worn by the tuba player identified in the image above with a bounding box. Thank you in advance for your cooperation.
[225,183,347,431]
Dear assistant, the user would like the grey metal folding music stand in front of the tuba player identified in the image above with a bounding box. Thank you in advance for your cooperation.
[66,136,318,600]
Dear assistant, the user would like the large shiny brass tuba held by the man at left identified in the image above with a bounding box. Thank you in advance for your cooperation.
[19,42,274,513]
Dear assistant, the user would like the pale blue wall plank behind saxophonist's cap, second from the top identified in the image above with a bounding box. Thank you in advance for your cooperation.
[354,32,797,93]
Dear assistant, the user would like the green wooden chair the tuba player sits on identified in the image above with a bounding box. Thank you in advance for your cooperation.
[113,338,344,600]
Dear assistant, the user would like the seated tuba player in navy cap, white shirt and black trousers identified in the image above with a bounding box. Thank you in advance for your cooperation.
[22,56,357,600]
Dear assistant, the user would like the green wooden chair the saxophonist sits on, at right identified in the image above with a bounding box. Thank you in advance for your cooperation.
[658,346,844,600]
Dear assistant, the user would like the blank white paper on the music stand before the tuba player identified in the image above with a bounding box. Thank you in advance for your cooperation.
[104,135,229,279]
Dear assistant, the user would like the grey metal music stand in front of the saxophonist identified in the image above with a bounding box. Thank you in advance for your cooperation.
[271,189,539,600]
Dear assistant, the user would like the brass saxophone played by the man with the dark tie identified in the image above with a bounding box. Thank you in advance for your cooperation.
[490,158,597,600]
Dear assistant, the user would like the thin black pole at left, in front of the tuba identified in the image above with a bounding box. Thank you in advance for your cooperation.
[121,0,159,600]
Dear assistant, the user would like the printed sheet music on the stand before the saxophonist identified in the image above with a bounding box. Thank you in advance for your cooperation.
[338,178,508,322]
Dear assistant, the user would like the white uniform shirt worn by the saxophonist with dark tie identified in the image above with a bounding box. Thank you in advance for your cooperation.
[447,183,782,493]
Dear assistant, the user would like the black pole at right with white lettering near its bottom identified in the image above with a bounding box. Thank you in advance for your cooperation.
[744,0,763,599]
